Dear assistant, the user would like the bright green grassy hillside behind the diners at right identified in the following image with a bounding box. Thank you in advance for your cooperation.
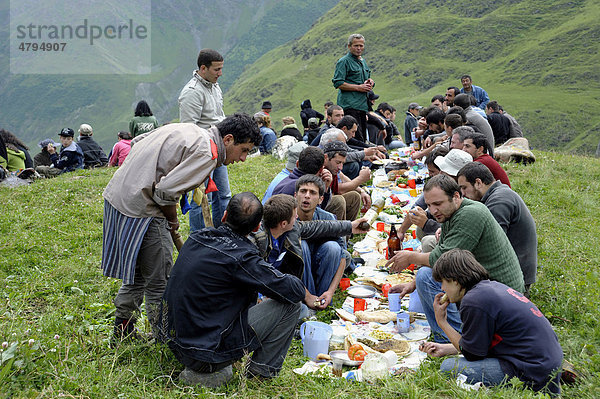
[226,0,600,152]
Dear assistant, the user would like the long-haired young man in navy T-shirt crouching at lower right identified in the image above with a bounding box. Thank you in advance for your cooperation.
[421,248,563,395]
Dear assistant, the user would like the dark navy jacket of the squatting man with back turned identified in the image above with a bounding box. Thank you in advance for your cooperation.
[163,225,305,363]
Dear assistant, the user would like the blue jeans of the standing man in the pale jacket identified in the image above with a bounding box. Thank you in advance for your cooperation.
[190,165,231,233]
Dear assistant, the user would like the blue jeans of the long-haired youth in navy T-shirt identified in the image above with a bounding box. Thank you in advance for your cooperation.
[440,356,508,386]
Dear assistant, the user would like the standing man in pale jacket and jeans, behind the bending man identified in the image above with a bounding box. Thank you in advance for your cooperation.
[179,49,231,231]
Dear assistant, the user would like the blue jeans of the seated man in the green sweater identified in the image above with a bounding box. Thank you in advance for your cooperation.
[416,266,462,343]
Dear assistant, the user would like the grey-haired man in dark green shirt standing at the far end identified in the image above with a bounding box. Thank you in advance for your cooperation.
[332,33,375,142]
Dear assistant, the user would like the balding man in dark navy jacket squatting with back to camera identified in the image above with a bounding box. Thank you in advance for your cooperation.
[162,192,305,388]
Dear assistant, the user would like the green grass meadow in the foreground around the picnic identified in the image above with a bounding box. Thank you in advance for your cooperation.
[0,152,600,398]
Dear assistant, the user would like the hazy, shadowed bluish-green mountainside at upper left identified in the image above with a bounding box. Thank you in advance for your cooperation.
[0,0,337,149]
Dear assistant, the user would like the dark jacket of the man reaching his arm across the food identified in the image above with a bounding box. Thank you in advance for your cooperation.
[248,220,352,280]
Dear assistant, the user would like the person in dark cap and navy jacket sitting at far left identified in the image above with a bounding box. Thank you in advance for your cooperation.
[36,127,83,177]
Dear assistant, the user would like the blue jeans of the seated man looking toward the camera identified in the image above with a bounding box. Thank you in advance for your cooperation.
[302,241,342,296]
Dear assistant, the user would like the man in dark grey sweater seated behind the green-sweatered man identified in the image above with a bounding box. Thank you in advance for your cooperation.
[458,162,537,297]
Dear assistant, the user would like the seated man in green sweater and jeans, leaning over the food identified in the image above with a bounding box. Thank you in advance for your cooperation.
[388,174,525,342]
